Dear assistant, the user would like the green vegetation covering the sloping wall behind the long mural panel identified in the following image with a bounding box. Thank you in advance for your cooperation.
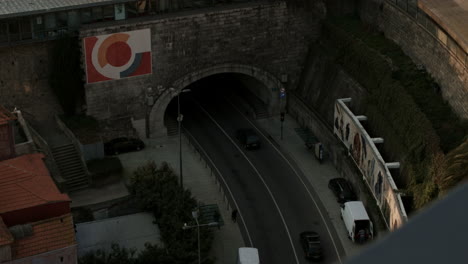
[323,18,468,208]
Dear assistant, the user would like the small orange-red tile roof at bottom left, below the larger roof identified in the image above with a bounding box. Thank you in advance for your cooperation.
[11,214,76,259]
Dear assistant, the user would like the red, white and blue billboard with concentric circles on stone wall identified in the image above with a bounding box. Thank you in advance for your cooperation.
[83,29,152,83]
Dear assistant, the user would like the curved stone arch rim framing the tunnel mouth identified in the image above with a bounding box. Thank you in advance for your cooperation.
[148,63,286,137]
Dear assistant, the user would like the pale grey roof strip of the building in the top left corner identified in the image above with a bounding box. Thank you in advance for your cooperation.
[0,0,129,18]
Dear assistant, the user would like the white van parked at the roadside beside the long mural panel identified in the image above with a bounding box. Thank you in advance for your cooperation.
[341,201,374,243]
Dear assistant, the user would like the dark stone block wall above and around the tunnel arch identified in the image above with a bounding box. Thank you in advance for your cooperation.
[81,2,318,135]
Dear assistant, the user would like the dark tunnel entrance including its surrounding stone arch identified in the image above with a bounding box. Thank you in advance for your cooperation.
[148,64,286,137]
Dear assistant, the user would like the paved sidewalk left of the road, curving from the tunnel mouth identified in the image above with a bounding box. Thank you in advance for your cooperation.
[119,136,245,264]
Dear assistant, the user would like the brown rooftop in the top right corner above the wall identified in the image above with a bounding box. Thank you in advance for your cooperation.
[418,0,468,52]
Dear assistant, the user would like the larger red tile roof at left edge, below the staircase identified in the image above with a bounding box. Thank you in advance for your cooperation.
[0,153,70,213]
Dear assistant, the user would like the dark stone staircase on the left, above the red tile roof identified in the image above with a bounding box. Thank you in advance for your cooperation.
[52,143,89,192]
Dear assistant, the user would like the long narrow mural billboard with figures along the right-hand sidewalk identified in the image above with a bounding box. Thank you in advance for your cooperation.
[333,99,407,229]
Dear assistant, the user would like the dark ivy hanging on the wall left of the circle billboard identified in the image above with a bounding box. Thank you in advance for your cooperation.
[49,36,84,115]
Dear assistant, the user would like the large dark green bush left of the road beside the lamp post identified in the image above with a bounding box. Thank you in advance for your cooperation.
[130,162,213,264]
